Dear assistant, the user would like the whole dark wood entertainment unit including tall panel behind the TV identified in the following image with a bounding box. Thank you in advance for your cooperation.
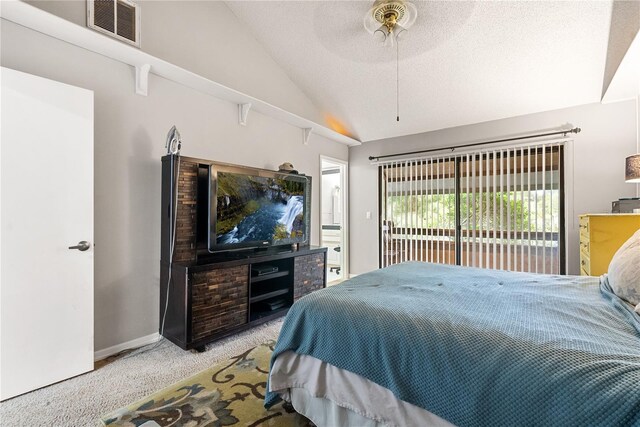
[159,156,327,351]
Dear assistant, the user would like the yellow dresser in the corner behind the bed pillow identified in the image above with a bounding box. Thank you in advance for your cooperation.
[580,214,640,276]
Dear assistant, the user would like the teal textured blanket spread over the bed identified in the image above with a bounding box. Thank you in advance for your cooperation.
[265,262,640,426]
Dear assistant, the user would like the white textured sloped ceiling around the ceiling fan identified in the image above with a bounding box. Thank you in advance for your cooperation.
[227,1,612,141]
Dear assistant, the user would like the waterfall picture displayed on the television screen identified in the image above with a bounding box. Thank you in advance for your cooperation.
[216,172,305,244]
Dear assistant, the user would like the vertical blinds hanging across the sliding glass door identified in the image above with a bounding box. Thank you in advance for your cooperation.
[379,143,564,274]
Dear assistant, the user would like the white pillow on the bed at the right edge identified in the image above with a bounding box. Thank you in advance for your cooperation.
[608,230,640,305]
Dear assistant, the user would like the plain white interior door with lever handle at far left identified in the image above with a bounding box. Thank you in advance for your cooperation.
[0,68,93,400]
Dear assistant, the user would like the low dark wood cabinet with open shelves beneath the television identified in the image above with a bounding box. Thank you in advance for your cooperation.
[160,247,327,351]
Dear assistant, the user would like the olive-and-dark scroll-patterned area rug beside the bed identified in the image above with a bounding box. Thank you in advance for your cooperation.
[101,341,313,427]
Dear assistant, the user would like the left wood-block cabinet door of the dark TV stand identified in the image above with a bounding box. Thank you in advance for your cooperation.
[190,265,249,342]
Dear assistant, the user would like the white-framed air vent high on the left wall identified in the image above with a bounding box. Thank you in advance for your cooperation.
[87,0,140,47]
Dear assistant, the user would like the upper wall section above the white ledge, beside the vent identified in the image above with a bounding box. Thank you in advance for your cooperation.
[27,0,323,123]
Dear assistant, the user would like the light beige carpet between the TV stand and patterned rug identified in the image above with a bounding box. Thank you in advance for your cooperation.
[0,319,282,427]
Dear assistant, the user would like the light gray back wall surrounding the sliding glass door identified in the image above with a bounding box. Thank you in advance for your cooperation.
[349,101,638,274]
